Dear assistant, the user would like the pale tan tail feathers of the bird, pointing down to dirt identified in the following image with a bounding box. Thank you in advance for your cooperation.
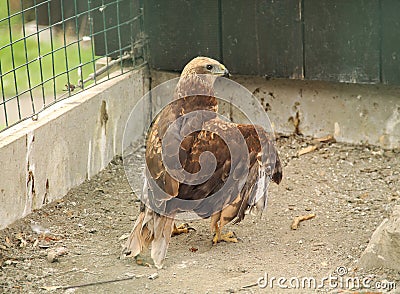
[123,207,174,268]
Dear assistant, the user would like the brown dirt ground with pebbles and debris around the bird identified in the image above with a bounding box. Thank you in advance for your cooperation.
[0,137,400,293]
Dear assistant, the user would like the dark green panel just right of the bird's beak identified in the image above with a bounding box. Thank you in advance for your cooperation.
[222,0,303,77]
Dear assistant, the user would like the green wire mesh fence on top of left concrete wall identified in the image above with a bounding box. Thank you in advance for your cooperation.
[0,0,147,131]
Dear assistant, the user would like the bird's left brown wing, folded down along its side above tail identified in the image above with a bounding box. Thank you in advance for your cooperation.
[142,96,216,213]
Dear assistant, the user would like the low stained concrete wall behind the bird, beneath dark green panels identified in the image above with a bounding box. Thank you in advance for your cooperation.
[151,71,400,148]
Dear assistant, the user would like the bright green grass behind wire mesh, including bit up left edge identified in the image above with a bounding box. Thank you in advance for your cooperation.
[0,0,96,100]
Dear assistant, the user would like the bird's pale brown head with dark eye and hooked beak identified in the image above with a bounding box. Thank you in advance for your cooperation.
[182,56,230,77]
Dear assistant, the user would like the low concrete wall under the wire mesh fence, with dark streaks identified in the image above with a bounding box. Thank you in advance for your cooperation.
[0,69,148,229]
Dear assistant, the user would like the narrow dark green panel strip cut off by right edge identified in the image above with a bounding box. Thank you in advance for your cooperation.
[381,0,400,85]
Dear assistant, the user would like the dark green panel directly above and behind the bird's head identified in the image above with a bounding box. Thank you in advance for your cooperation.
[144,0,221,70]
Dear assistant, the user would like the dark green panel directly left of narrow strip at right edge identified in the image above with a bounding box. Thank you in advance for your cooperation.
[304,0,380,83]
